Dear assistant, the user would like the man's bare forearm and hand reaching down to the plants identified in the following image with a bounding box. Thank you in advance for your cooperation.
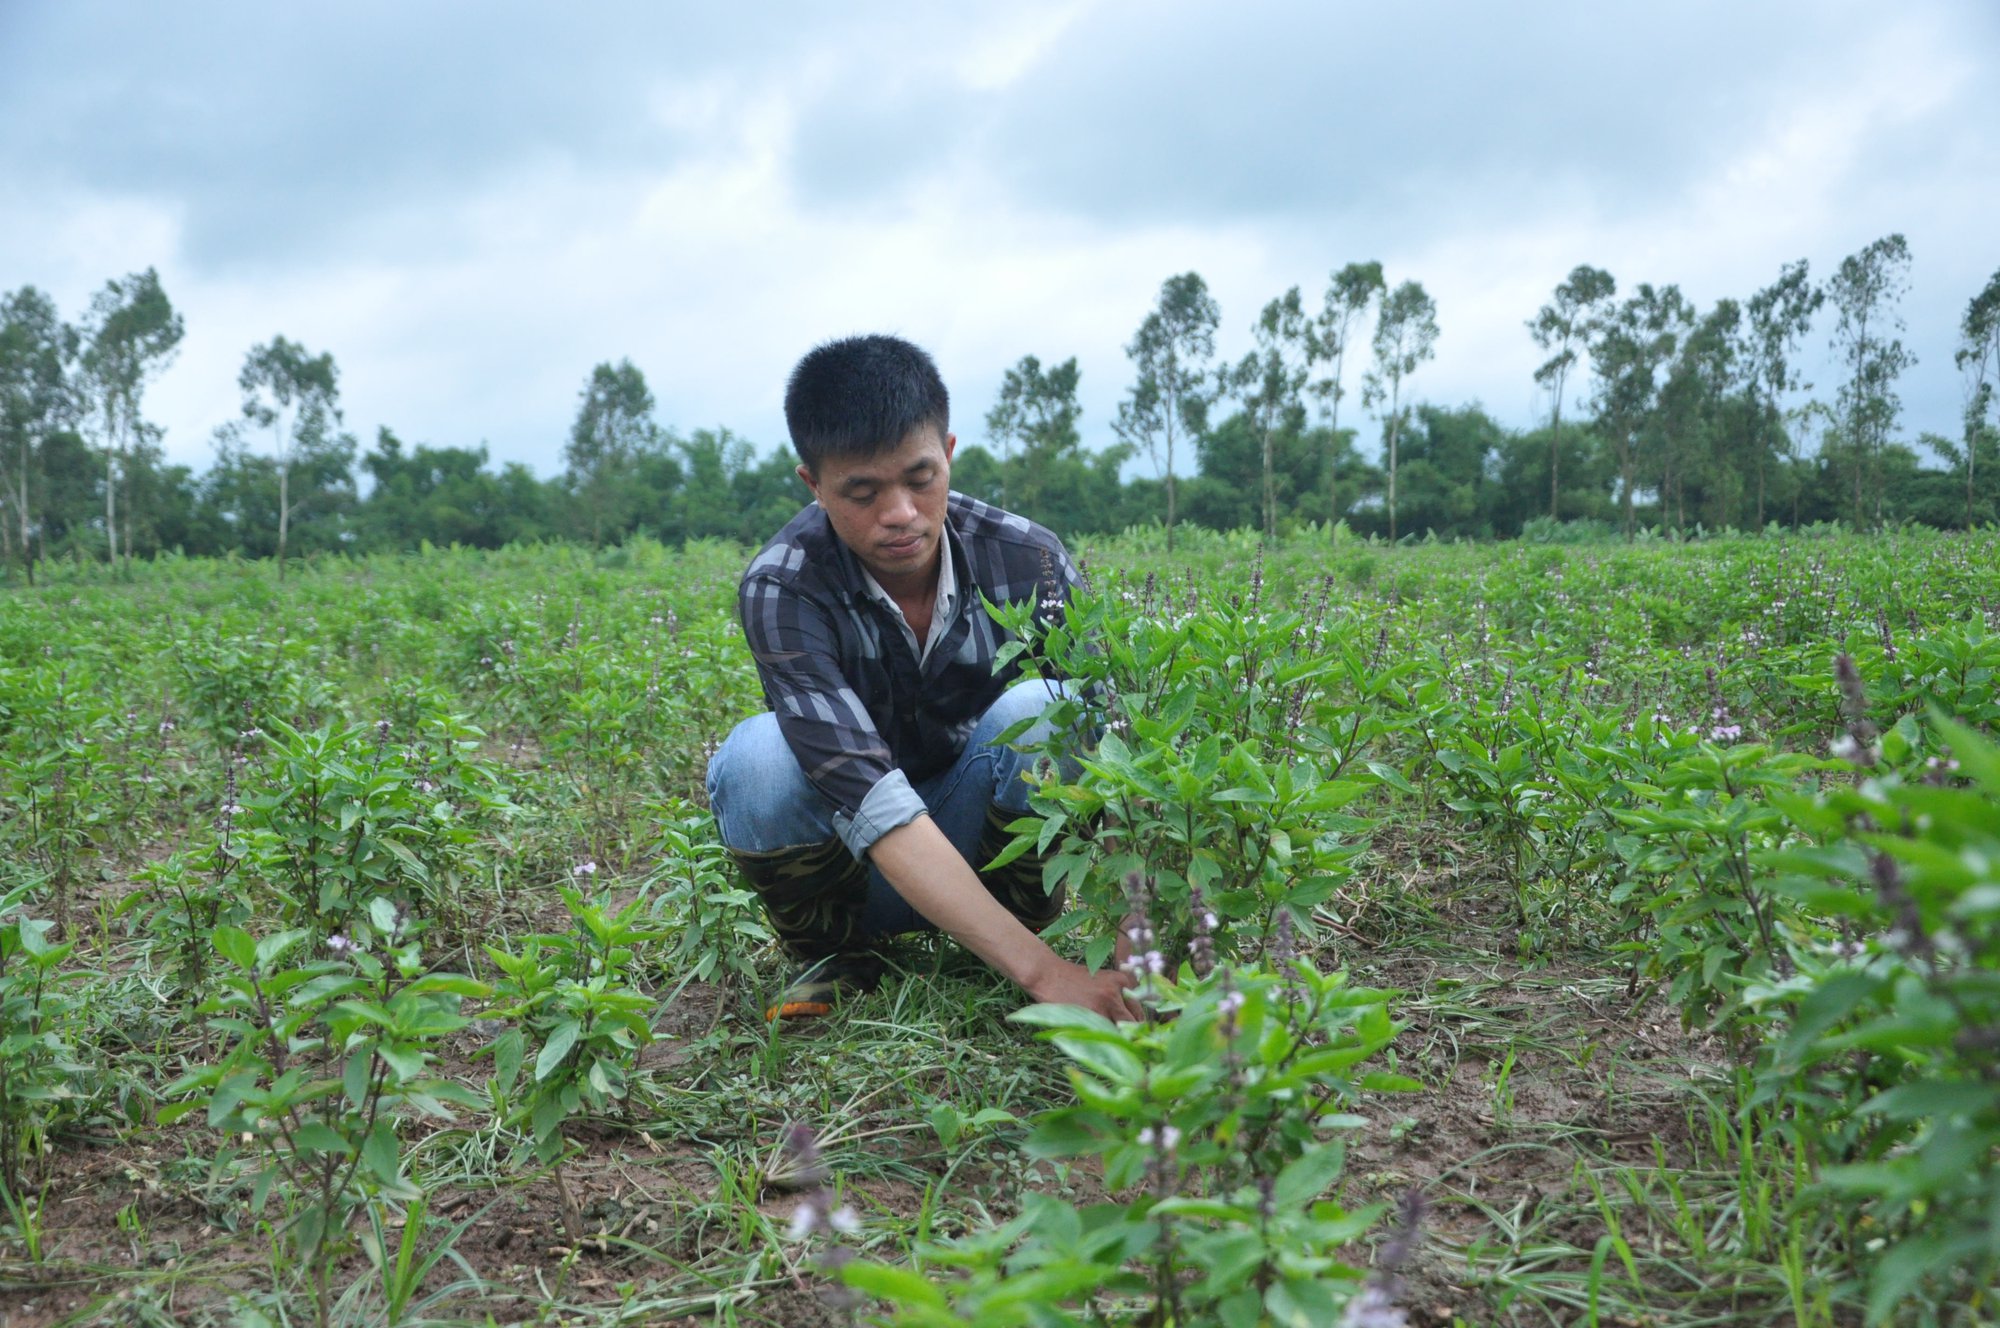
[868,816,1144,1020]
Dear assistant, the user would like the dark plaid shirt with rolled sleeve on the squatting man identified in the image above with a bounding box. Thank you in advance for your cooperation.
[738,492,1078,858]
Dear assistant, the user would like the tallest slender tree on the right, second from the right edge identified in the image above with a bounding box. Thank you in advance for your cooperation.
[1826,234,1916,526]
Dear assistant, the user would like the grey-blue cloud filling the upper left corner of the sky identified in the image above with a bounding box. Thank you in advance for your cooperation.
[0,2,804,268]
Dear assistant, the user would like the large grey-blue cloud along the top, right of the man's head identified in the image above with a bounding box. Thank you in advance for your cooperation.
[796,0,1994,240]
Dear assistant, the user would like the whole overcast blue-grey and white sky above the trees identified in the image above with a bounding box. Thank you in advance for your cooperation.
[0,0,2000,474]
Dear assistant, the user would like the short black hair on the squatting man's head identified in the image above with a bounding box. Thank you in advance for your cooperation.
[784,336,952,474]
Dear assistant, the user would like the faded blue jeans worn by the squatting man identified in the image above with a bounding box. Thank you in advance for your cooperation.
[708,678,1066,938]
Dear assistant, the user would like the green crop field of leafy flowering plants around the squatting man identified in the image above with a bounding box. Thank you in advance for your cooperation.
[0,530,2000,1328]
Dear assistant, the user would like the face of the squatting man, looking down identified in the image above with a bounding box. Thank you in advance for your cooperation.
[798,428,958,594]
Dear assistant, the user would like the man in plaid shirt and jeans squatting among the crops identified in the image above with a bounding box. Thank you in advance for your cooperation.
[708,336,1140,1018]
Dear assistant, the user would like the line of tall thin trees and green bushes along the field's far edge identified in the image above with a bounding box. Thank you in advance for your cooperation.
[0,234,2000,580]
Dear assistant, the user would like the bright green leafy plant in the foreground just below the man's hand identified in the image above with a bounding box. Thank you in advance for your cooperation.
[840,962,1418,1328]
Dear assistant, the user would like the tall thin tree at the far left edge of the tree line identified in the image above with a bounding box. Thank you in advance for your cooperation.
[0,286,78,586]
